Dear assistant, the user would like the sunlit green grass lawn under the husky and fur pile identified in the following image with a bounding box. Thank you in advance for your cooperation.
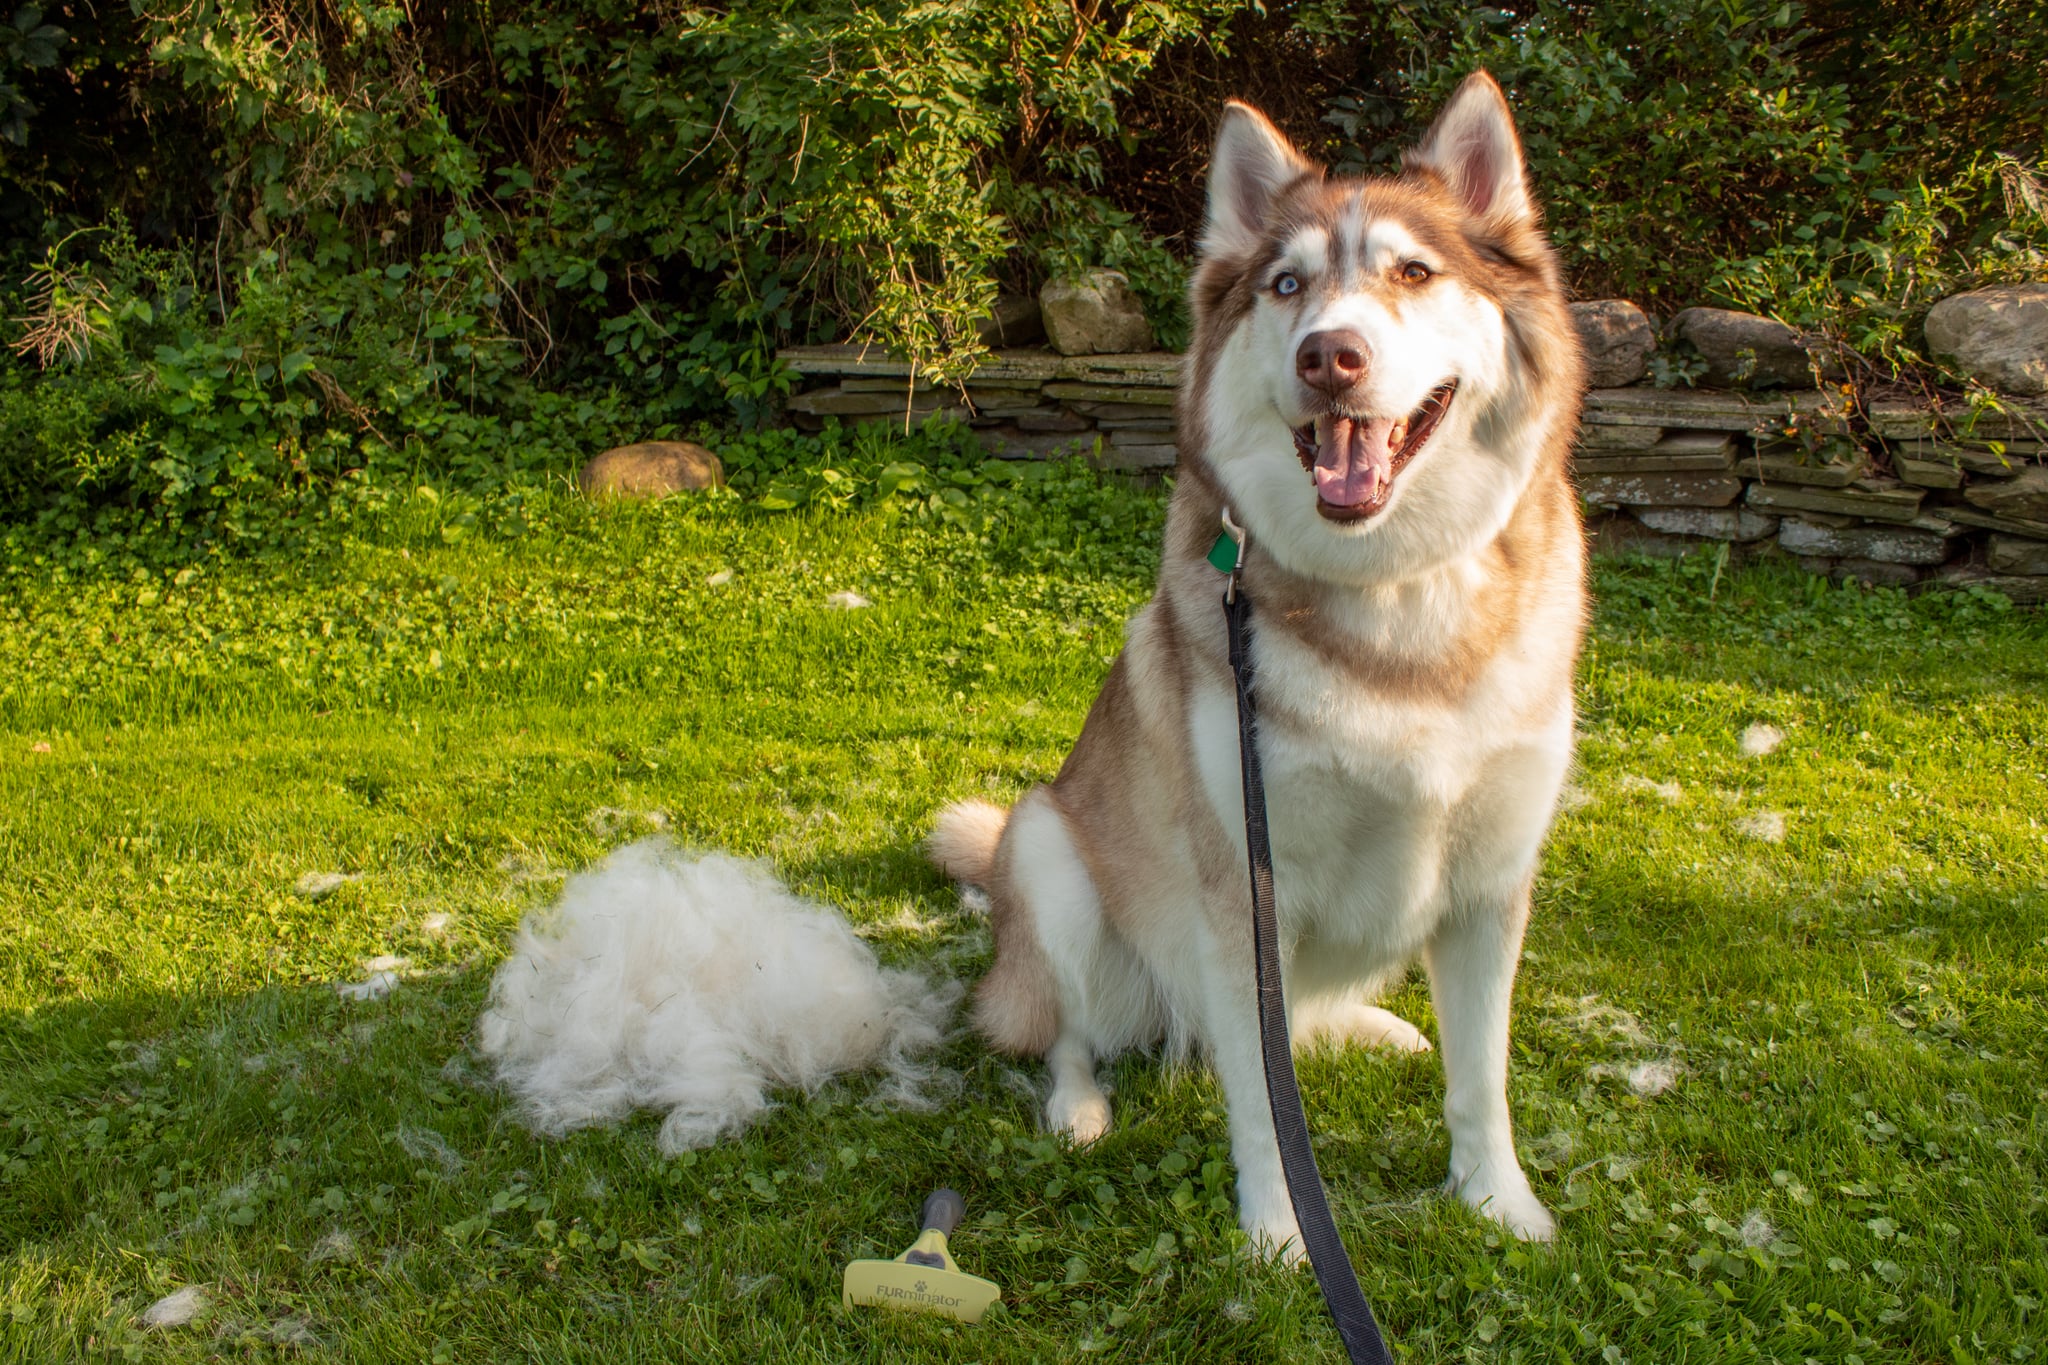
[0,475,2048,1365]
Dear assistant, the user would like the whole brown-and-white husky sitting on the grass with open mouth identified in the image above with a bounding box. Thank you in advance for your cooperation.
[932,72,1585,1259]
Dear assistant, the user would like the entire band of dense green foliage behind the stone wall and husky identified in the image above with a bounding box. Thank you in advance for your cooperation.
[0,0,2048,530]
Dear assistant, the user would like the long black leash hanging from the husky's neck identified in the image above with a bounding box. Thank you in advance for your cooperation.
[1208,512,1393,1365]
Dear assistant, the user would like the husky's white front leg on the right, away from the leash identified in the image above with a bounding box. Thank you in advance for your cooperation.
[1427,890,1556,1242]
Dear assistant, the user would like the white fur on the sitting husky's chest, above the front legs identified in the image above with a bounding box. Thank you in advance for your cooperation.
[1192,560,1571,976]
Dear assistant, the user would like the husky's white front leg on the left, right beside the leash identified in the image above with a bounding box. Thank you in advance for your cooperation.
[1202,925,1305,1263]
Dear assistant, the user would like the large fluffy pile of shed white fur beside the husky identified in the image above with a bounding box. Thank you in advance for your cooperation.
[477,839,961,1152]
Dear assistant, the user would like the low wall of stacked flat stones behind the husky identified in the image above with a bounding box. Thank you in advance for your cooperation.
[782,341,2048,604]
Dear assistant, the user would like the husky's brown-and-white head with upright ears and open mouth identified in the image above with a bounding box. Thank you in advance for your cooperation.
[1190,72,1581,581]
